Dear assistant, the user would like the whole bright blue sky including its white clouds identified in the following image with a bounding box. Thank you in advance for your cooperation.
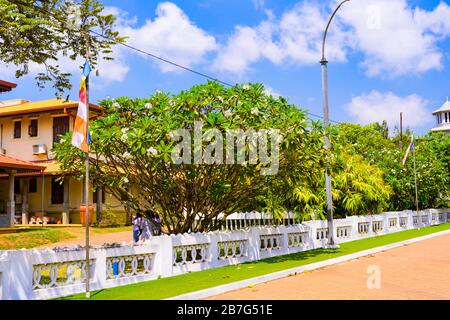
[0,0,450,134]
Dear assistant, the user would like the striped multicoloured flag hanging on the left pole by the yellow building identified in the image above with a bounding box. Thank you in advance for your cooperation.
[72,60,91,152]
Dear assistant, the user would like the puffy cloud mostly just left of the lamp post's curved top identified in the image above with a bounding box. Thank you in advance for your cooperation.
[213,2,349,75]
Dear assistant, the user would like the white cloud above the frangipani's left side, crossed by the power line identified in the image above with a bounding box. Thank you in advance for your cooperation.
[119,2,217,72]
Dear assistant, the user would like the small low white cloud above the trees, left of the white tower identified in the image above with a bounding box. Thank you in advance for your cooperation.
[346,90,432,128]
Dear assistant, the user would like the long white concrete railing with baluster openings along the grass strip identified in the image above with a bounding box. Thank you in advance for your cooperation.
[0,209,450,299]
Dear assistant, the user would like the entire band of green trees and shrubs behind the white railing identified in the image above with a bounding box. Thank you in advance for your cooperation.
[53,82,450,232]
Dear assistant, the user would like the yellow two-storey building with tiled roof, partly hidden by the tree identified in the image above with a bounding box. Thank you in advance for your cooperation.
[0,82,124,226]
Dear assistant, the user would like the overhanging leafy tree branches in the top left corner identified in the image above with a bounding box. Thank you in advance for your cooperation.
[0,0,125,96]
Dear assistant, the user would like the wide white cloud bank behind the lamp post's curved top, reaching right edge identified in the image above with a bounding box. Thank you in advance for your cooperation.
[213,0,450,77]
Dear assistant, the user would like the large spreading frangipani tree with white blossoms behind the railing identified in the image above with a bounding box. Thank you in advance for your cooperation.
[54,82,323,232]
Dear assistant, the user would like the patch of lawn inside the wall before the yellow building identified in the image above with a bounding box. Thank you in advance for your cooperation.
[0,228,75,250]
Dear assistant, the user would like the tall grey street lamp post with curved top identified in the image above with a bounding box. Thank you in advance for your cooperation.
[320,0,350,248]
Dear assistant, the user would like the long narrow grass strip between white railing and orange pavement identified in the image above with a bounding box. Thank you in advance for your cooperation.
[60,223,450,300]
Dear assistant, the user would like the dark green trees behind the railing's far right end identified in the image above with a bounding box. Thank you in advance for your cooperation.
[334,123,450,210]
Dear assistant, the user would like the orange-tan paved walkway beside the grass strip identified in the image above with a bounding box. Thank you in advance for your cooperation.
[209,235,450,300]
